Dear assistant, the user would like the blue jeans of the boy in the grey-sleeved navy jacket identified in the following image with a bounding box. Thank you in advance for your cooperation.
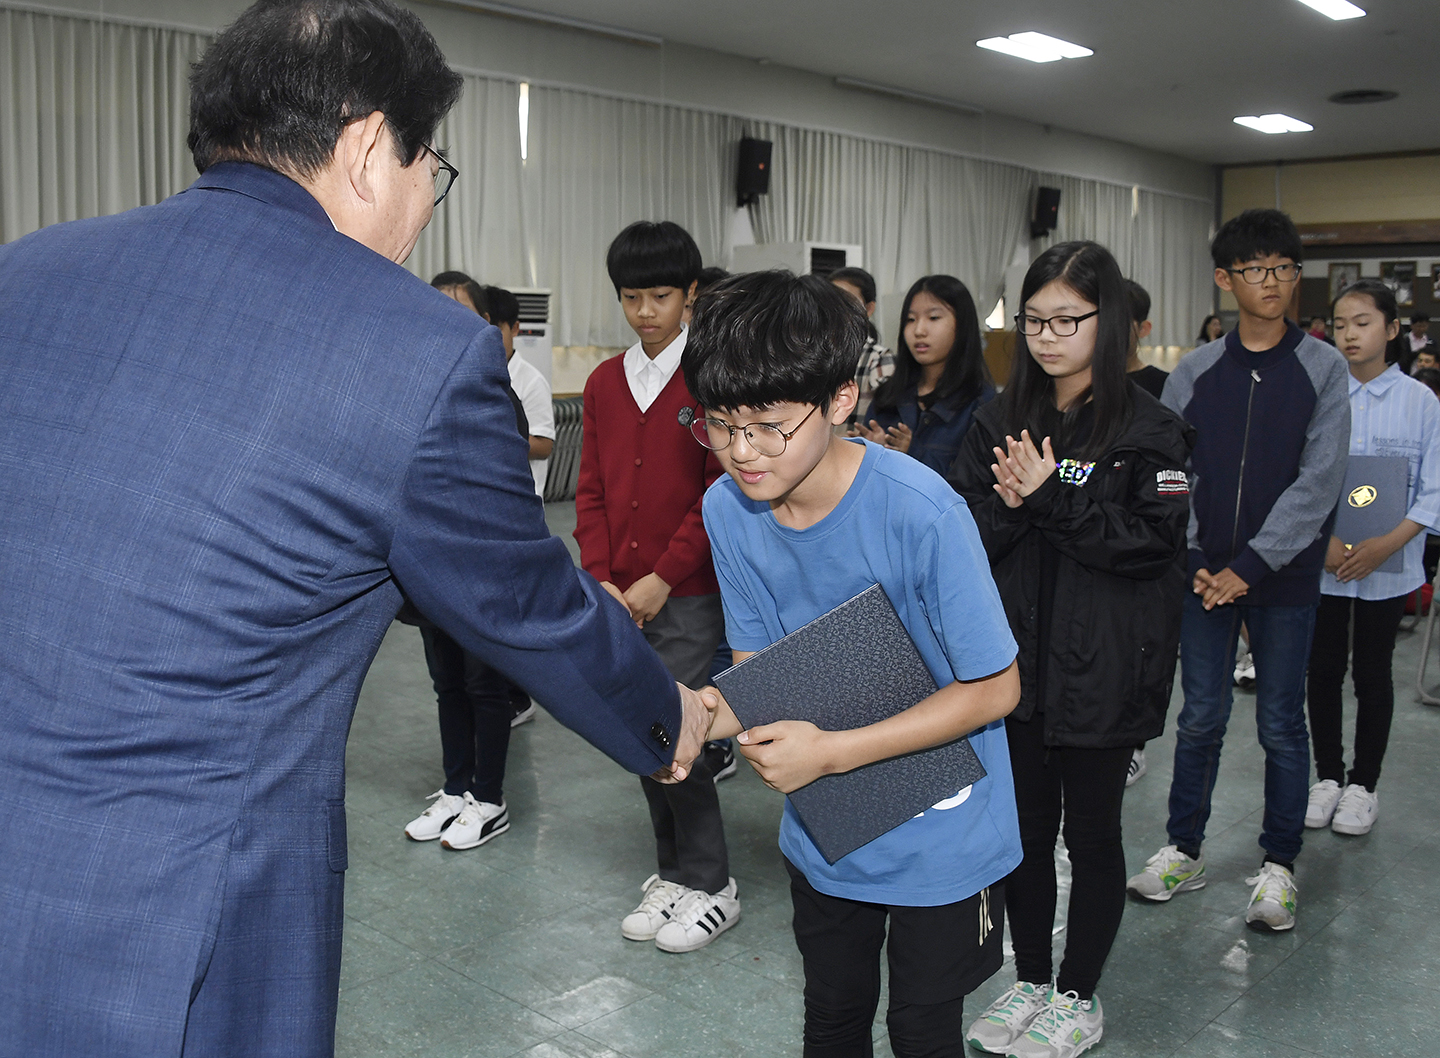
[1166,594,1315,864]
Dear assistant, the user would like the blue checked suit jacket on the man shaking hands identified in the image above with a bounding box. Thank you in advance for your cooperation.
[0,164,680,1058]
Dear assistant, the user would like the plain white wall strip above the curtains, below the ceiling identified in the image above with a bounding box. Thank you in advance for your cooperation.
[25,0,1214,199]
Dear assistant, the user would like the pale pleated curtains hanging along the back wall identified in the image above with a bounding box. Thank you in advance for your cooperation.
[0,0,1211,347]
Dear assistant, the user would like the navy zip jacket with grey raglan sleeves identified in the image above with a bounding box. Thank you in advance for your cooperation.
[1162,324,1349,606]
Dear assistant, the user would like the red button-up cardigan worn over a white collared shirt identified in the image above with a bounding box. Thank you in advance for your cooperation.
[575,353,721,596]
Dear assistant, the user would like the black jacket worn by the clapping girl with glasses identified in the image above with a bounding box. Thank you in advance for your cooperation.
[950,386,1194,749]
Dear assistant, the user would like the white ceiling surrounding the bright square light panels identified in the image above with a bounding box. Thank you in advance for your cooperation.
[495,0,1440,163]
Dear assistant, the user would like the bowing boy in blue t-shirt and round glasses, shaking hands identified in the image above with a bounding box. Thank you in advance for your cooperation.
[681,272,1021,1058]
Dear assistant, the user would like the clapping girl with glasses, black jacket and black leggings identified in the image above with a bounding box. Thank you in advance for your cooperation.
[953,242,1192,1058]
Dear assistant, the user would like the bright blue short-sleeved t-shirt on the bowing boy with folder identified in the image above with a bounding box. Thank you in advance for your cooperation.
[701,442,1021,907]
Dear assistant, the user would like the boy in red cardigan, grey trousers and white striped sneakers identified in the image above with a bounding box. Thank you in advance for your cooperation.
[575,220,740,951]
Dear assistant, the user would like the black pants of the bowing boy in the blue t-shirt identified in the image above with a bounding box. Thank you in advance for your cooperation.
[785,859,1005,1058]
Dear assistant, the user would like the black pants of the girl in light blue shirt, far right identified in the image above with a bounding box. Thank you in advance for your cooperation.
[1306,594,1408,793]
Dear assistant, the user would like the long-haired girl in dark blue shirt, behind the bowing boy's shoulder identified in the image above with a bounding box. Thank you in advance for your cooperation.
[857,275,995,476]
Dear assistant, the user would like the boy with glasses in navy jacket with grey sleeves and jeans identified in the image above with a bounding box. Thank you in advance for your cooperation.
[1129,209,1351,930]
